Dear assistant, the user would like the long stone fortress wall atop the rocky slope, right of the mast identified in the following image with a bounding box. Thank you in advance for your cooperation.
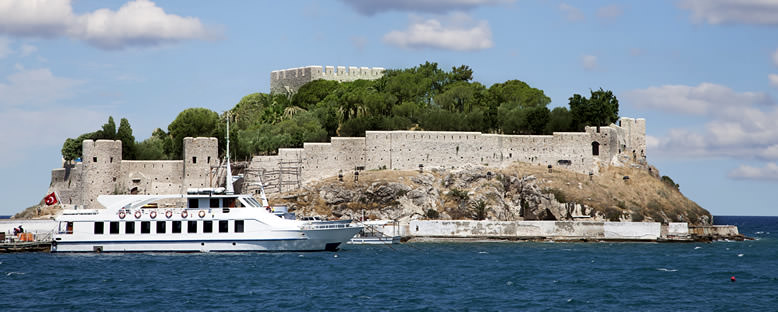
[246,117,646,192]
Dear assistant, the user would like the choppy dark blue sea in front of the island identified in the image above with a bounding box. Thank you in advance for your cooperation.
[0,217,778,311]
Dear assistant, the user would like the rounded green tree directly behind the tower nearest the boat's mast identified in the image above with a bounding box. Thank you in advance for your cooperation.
[166,108,219,159]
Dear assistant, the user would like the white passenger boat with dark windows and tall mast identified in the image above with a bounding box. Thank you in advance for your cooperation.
[51,120,362,252]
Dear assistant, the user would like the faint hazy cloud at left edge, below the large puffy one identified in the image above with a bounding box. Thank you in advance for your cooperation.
[0,64,84,111]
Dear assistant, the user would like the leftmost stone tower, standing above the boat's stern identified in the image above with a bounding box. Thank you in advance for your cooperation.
[82,140,122,208]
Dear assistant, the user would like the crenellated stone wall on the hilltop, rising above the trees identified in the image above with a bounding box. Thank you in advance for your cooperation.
[270,66,384,93]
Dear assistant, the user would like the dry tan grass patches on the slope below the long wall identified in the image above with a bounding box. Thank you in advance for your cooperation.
[266,163,710,224]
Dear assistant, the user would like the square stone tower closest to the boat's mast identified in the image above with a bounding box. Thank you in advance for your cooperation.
[181,137,219,192]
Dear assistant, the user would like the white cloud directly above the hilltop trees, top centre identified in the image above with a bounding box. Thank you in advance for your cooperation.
[383,13,494,51]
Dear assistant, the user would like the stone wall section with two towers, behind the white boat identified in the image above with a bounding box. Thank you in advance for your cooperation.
[49,138,219,208]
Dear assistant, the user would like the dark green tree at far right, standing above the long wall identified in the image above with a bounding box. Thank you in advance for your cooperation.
[569,88,619,131]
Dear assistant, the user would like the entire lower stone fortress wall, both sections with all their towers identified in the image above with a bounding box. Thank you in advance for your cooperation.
[49,118,646,208]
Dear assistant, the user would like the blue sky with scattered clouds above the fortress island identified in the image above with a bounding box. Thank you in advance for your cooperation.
[0,0,778,216]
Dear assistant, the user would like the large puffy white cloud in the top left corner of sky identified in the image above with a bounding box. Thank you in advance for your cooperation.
[0,0,214,49]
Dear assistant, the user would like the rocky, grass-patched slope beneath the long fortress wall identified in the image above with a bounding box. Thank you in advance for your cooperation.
[266,165,711,225]
